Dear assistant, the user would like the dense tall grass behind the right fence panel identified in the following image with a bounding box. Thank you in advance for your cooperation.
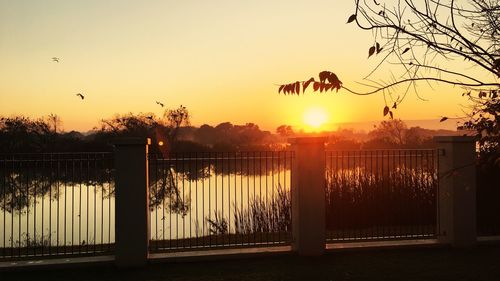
[326,166,437,238]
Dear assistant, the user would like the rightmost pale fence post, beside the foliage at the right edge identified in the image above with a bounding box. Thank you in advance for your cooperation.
[434,136,477,247]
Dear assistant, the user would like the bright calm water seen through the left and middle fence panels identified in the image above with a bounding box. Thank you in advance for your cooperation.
[0,166,290,247]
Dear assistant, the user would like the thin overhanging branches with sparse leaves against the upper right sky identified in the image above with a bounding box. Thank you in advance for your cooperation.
[278,0,500,117]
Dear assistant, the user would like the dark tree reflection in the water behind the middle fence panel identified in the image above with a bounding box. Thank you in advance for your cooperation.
[149,151,291,216]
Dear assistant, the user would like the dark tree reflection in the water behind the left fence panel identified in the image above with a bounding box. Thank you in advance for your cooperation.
[0,154,114,213]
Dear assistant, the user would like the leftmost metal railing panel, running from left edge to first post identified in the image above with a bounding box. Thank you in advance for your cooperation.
[0,153,115,259]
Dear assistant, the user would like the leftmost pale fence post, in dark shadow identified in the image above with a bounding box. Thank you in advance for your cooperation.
[114,138,150,267]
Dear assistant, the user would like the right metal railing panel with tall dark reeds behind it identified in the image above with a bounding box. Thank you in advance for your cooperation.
[326,150,438,242]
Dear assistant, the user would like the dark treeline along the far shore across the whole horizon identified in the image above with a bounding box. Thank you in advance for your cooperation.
[0,111,457,153]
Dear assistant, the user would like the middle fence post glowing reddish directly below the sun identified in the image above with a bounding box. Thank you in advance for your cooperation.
[289,137,325,256]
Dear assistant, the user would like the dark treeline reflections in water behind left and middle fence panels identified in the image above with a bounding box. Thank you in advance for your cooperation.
[0,151,291,218]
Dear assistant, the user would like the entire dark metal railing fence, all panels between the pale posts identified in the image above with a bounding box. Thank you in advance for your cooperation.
[4,149,498,260]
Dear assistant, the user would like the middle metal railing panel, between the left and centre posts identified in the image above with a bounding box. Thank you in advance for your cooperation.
[149,151,293,251]
